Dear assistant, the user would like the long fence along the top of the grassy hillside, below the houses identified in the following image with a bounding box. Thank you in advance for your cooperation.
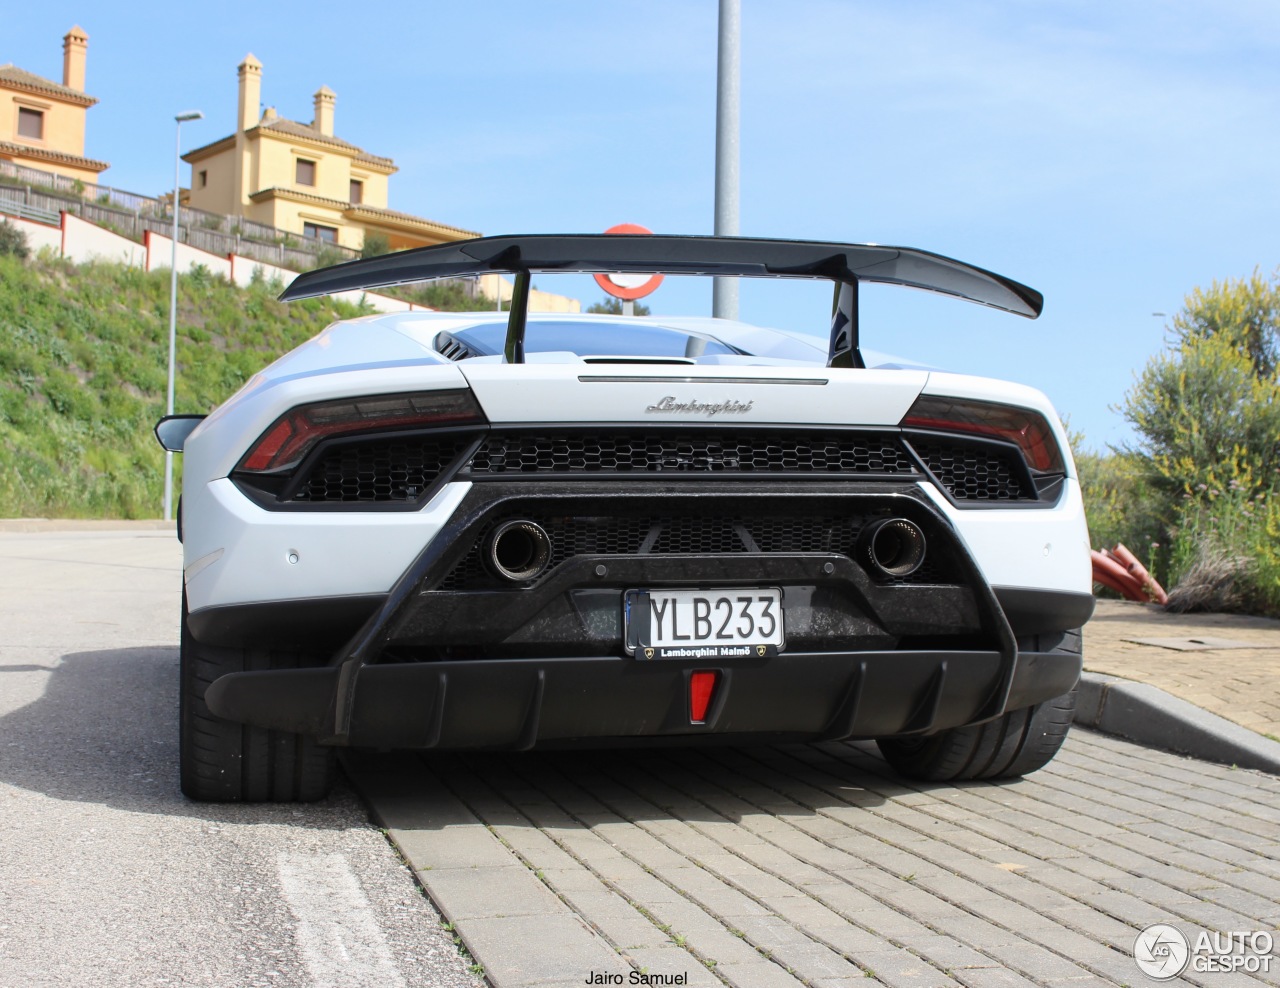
[0,161,360,270]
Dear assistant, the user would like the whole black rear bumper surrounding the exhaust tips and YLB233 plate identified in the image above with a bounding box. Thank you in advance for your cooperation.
[189,484,1093,749]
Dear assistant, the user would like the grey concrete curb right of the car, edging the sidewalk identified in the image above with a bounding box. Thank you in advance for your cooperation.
[1075,672,1280,774]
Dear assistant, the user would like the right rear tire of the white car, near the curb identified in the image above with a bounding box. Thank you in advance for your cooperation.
[876,630,1080,782]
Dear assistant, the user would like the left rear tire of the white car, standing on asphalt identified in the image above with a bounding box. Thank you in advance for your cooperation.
[178,594,334,802]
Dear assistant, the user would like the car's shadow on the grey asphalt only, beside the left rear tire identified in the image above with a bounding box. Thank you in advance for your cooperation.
[0,646,362,829]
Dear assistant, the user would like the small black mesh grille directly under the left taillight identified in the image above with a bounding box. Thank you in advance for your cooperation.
[289,435,475,503]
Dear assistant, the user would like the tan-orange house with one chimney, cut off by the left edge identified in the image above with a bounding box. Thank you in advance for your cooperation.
[0,27,109,183]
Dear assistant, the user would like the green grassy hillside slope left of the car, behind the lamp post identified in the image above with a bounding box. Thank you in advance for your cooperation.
[0,256,373,518]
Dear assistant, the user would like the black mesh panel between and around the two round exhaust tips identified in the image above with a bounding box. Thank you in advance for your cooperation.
[435,511,955,591]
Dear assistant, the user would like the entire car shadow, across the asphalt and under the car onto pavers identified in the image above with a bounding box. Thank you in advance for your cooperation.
[0,646,1000,829]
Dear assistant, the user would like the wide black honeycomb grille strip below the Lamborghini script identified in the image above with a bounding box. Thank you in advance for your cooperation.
[467,430,916,476]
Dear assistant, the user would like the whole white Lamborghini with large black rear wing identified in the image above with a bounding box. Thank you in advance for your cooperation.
[157,235,1093,800]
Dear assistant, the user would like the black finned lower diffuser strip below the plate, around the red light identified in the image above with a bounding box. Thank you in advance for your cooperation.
[205,651,1080,750]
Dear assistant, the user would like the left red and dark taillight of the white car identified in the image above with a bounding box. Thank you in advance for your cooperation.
[239,390,485,474]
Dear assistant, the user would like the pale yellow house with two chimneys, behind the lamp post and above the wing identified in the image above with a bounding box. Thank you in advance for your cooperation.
[182,55,479,250]
